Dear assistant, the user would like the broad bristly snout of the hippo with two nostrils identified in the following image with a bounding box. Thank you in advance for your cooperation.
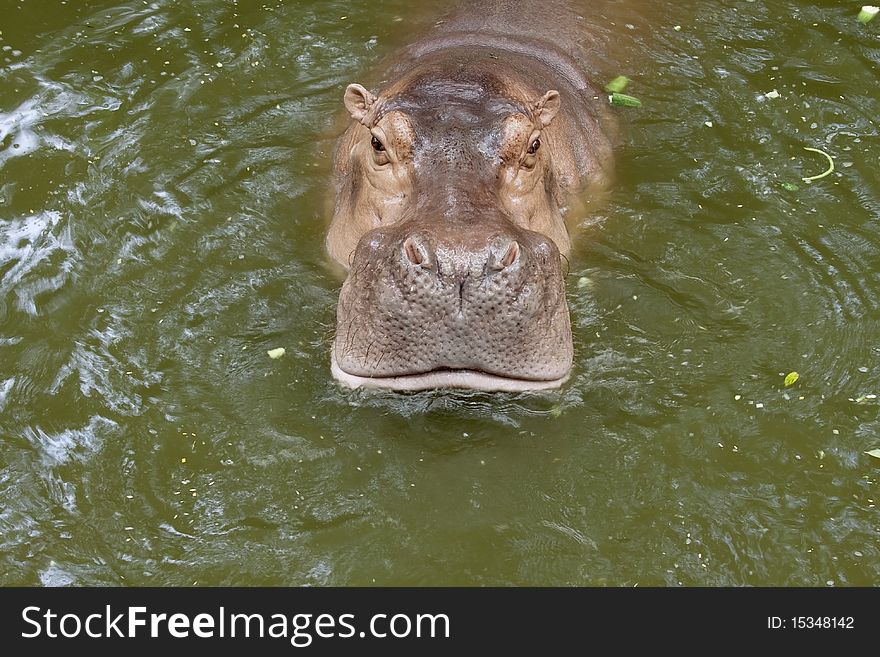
[334,222,572,390]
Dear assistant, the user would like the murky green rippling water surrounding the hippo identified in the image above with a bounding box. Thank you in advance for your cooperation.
[0,0,880,586]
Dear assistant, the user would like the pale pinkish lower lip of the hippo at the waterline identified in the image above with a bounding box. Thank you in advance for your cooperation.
[330,346,569,392]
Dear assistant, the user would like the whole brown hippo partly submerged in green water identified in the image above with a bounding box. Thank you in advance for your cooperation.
[326,0,613,392]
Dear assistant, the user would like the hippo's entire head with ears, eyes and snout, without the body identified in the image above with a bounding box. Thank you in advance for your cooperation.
[327,71,572,391]
